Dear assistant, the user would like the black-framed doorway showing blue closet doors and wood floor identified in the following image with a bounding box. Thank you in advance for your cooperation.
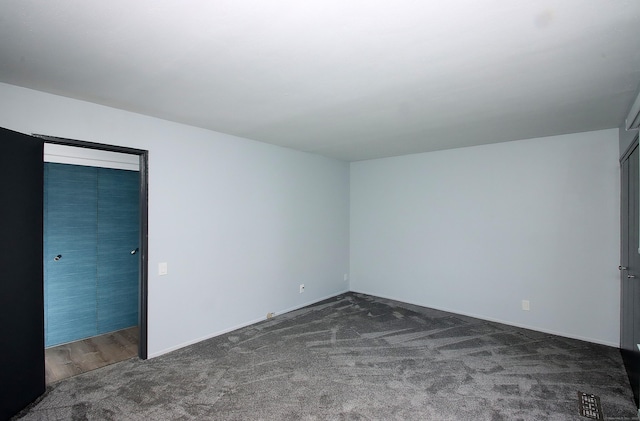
[34,135,148,384]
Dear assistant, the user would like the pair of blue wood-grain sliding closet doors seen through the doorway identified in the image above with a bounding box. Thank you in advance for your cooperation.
[44,163,140,347]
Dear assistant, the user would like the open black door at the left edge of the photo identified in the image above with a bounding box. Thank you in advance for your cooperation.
[0,128,45,419]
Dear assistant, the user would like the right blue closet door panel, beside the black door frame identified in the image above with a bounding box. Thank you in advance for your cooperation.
[97,168,140,334]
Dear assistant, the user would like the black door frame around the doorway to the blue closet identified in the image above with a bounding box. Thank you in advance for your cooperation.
[33,134,149,360]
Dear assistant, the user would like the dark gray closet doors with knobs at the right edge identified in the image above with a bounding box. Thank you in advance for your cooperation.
[619,136,640,406]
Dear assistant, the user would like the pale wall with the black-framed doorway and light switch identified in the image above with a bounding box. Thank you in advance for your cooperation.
[0,84,349,356]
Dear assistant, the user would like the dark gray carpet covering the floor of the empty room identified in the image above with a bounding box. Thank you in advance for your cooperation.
[18,293,637,421]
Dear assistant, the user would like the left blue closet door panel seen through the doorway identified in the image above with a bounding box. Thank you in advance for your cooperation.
[44,163,98,347]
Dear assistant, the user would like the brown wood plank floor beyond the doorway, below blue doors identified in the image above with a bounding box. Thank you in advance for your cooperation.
[44,327,138,384]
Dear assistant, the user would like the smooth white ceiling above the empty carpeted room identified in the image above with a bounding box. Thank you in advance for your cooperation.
[0,0,640,161]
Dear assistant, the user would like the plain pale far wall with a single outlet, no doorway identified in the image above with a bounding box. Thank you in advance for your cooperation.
[350,129,620,346]
